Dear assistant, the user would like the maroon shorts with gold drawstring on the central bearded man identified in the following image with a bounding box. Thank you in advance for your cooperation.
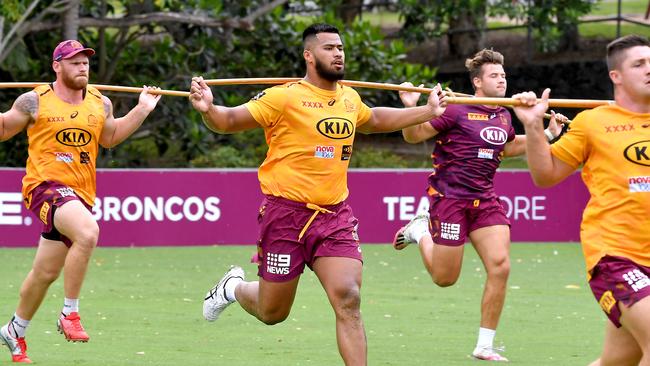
[257,196,362,282]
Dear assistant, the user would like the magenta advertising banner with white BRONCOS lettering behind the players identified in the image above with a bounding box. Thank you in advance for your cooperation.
[0,169,589,247]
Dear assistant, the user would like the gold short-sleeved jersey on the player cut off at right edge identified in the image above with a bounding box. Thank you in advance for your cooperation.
[551,105,650,271]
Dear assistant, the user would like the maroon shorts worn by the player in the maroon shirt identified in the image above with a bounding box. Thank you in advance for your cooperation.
[429,197,510,247]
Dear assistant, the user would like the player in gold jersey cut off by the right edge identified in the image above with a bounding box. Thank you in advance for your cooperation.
[515,35,650,366]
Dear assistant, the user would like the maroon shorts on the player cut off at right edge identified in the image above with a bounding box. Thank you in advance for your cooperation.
[589,255,650,328]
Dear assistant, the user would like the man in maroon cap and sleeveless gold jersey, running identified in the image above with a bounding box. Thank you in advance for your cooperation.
[0,40,160,363]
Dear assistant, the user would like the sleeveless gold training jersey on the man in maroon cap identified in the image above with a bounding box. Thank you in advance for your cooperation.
[23,85,105,207]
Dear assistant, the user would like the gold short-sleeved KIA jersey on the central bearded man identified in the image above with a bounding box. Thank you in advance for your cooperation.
[245,80,372,205]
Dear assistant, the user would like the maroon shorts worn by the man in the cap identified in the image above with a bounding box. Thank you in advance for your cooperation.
[25,181,92,248]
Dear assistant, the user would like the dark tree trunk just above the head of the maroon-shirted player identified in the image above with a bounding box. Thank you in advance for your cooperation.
[447,2,486,57]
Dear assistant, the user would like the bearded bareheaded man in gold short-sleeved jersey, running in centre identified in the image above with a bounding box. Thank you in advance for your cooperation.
[190,24,445,365]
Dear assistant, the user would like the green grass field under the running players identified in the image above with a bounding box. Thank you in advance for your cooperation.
[0,244,605,366]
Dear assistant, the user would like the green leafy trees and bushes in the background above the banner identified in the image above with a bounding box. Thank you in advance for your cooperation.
[0,0,591,167]
